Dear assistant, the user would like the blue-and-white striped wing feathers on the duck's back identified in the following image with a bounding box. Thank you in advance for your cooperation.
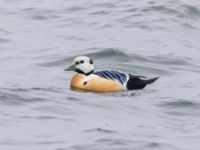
[94,70,129,85]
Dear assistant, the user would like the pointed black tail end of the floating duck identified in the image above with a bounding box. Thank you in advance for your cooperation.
[127,75,159,90]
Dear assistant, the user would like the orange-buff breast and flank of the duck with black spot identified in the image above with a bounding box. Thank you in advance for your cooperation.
[71,74,126,92]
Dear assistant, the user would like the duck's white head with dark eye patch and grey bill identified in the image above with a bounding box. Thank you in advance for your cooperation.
[65,56,94,75]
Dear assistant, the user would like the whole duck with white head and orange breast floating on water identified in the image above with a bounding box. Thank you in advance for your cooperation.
[65,56,158,92]
